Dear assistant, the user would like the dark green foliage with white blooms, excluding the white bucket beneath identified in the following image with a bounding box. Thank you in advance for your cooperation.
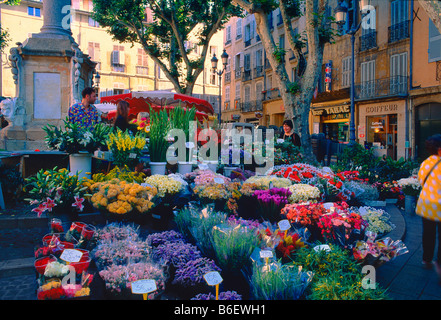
[42,119,112,154]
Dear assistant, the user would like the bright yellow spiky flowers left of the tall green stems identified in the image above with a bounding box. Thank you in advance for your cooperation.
[107,129,146,170]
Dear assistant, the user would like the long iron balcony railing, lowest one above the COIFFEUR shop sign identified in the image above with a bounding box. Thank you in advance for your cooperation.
[355,76,408,100]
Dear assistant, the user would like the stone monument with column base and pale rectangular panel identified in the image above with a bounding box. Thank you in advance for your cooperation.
[0,0,96,151]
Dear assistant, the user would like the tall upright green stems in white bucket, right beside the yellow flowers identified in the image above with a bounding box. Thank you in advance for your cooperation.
[149,109,170,175]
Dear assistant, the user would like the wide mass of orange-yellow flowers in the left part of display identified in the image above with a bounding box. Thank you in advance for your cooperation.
[90,179,158,215]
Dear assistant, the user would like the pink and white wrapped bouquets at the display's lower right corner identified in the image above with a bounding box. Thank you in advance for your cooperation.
[353,231,409,267]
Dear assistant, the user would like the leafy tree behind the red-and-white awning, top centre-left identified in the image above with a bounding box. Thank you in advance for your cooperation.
[92,0,241,94]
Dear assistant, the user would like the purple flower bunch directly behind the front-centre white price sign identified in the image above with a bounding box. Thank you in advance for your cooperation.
[173,258,221,287]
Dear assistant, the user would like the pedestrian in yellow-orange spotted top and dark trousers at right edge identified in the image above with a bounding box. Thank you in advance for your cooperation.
[416,134,441,284]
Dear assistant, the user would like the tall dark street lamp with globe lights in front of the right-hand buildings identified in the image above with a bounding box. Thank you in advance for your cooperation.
[335,0,370,144]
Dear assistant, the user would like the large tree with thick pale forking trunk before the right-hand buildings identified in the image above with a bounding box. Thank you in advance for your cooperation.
[233,0,336,160]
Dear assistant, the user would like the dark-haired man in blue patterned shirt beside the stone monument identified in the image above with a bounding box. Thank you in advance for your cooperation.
[68,87,100,129]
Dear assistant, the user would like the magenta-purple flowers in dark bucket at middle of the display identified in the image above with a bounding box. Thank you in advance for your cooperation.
[253,188,291,222]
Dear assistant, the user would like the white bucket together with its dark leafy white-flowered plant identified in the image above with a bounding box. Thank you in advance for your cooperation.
[42,119,111,178]
